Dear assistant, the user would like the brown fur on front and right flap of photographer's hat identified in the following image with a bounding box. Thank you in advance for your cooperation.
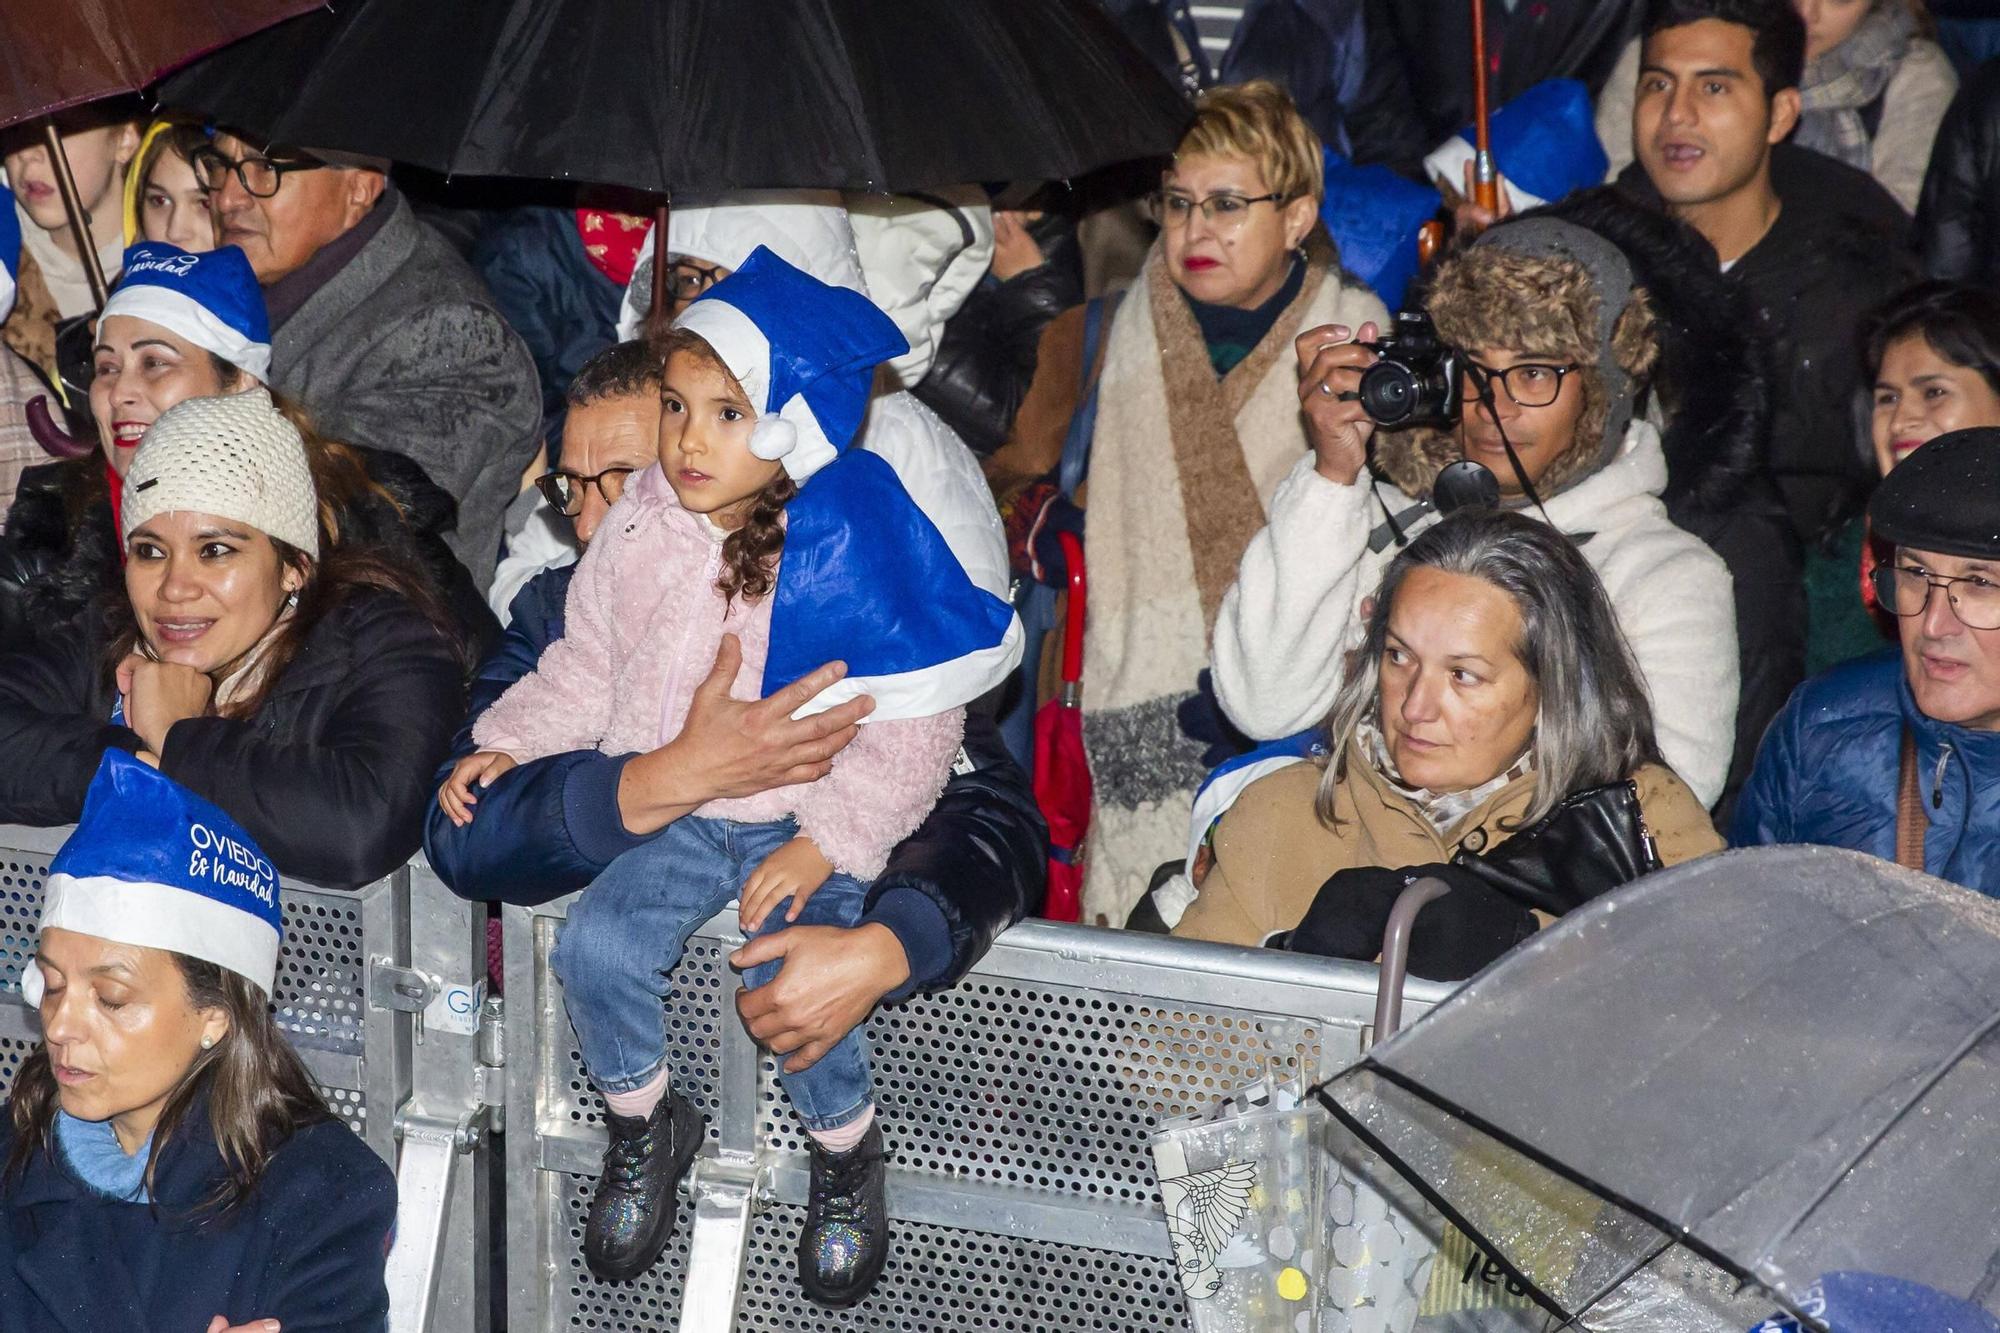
[1424,246,1660,494]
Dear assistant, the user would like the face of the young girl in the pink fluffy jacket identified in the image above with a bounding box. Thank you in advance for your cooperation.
[660,350,784,530]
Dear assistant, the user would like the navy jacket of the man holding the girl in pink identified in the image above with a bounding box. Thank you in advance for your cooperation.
[424,564,1048,999]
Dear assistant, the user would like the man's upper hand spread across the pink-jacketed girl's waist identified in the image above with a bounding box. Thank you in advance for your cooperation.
[618,634,874,835]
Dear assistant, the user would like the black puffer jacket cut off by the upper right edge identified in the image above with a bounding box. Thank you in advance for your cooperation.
[1916,58,2000,286]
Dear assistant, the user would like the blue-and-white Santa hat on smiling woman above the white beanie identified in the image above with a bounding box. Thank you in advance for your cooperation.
[98,240,270,380]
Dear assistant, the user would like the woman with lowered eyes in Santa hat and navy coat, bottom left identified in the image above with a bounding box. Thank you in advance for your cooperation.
[0,751,396,1333]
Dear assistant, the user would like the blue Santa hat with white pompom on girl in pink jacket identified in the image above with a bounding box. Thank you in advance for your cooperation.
[674,246,910,482]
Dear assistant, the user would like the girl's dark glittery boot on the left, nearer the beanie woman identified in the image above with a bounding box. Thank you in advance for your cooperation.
[584,1091,708,1281]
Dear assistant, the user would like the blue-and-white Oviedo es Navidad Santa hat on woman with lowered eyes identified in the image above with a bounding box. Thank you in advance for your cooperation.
[20,749,284,1007]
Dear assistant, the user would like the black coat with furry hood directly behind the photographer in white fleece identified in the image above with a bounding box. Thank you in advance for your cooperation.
[1546,188,1806,829]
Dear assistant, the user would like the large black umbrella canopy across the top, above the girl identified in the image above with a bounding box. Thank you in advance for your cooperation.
[160,0,1188,194]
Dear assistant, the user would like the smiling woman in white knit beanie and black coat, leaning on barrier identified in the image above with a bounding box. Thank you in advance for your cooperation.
[0,368,464,889]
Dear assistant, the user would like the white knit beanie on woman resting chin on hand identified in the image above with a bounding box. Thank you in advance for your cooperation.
[120,388,320,558]
